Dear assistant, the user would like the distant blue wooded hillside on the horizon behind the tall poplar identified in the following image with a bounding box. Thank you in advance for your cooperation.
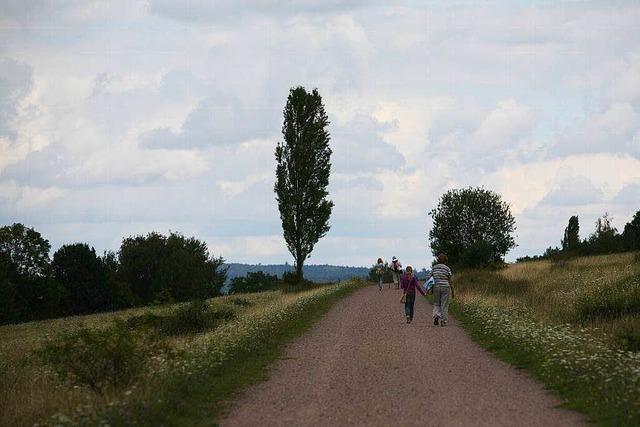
[226,263,369,283]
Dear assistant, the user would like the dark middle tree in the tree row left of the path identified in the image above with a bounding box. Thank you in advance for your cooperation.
[51,243,112,314]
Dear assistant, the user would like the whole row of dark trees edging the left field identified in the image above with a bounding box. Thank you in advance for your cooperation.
[0,223,226,324]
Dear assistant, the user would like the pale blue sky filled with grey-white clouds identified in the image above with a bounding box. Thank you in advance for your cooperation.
[0,0,640,266]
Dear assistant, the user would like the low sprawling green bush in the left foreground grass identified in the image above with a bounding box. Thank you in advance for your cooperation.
[38,321,152,393]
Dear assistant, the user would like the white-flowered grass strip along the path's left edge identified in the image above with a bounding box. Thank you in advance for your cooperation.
[97,283,358,426]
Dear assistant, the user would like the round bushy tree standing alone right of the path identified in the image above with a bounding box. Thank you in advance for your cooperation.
[429,187,516,265]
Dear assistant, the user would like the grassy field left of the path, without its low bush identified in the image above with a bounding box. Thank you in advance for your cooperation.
[0,281,361,426]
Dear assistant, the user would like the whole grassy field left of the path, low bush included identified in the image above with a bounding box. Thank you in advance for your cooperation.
[0,282,360,426]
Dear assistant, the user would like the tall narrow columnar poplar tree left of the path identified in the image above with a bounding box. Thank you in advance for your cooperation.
[274,87,333,280]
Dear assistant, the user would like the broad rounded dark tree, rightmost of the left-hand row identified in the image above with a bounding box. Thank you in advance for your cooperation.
[118,232,226,303]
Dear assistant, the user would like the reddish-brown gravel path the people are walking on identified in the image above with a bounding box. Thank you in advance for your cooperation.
[221,287,585,426]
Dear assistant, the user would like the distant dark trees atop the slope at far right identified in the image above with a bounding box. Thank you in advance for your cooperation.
[518,211,640,261]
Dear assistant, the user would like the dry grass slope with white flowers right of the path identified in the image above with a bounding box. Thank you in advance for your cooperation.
[452,253,640,425]
